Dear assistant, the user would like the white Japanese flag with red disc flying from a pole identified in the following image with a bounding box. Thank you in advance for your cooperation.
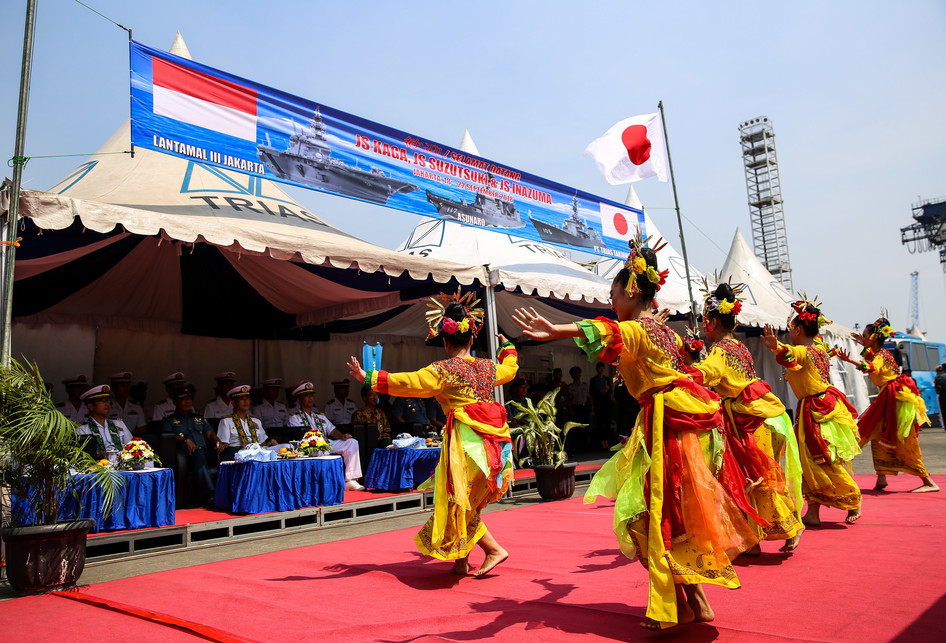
[585,113,670,185]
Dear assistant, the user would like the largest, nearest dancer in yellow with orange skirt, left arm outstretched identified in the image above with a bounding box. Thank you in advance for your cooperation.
[513,239,758,630]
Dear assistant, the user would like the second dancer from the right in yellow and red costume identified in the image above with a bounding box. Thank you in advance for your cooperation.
[762,295,861,526]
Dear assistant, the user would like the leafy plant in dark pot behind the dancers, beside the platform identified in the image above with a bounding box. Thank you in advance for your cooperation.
[510,389,587,500]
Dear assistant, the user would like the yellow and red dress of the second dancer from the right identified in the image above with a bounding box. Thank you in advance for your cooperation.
[775,342,861,511]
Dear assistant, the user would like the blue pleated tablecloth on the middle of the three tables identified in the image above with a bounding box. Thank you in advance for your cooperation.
[214,455,345,514]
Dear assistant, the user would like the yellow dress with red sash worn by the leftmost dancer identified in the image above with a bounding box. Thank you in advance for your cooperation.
[365,342,519,560]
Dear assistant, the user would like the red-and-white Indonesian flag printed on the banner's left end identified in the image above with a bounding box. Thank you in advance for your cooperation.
[151,58,256,143]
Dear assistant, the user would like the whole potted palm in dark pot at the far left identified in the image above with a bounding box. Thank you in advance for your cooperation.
[0,360,121,595]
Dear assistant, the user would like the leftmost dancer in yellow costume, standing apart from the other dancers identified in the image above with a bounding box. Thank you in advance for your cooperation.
[348,293,519,576]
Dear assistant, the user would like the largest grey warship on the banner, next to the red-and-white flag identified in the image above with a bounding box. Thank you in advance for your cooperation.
[256,110,417,205]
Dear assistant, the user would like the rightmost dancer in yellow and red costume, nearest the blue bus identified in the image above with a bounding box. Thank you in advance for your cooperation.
[838,315,939,493]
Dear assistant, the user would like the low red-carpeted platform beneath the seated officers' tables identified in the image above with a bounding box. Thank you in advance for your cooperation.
[42,464,601,567]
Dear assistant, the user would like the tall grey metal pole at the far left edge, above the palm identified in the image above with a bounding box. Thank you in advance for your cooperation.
[0,0,36,367]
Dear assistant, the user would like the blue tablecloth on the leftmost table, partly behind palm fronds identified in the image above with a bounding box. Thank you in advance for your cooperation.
[51,469,174,533]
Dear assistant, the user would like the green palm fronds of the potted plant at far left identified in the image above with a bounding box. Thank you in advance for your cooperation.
[0,359,122,527]
